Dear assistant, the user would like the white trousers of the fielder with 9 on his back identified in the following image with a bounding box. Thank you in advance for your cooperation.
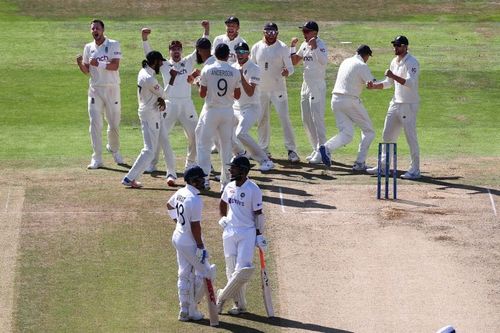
[195,105,234,186]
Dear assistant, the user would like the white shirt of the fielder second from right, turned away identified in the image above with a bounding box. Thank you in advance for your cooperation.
[332,54,375,98]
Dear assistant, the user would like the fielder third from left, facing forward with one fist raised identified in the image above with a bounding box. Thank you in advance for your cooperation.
[142,28,198,186]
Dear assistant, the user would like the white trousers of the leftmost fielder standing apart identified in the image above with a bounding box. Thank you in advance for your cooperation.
[88,85,121,162]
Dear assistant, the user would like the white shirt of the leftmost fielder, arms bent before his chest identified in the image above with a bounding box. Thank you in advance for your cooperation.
[83,37,122,87]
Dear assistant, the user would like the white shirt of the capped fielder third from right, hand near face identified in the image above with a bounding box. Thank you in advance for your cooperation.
[297,37,328,83]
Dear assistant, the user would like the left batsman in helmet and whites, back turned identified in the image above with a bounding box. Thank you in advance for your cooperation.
[167,166,215,321]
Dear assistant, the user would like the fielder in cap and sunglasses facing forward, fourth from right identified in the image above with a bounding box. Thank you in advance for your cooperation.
[250,22,300,163]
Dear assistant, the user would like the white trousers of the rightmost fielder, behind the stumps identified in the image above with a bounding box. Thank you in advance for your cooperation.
[382,100,420,173]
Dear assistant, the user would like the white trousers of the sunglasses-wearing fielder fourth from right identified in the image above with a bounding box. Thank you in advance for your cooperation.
[258,91,297,151]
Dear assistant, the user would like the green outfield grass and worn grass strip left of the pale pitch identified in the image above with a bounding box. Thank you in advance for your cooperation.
[0,0,500,332]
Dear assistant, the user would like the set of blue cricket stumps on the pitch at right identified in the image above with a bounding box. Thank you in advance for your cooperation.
[377,142,398,199]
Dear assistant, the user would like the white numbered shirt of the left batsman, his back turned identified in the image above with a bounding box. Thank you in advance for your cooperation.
[168,184,203,245]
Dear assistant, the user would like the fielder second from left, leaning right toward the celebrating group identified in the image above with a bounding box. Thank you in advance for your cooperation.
[122,51,170,188]
